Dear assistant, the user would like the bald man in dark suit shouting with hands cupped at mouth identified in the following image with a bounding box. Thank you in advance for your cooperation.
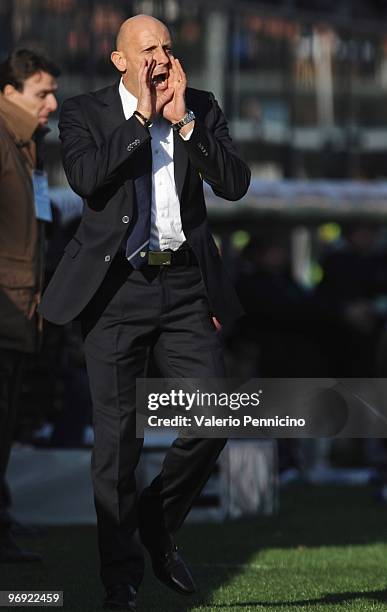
[40,15,250,609]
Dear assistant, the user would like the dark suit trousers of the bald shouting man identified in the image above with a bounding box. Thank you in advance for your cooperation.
[82,258,226,587]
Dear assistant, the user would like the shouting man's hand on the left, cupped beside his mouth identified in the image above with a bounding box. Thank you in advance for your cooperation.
[136,59,173,119]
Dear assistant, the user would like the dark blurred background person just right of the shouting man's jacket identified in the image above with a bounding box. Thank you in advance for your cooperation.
[236,228,326,378]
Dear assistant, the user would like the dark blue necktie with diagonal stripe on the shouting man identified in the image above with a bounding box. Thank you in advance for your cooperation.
[126,172,152,270]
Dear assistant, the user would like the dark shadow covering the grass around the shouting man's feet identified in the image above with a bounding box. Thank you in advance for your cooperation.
[0,487,387,612]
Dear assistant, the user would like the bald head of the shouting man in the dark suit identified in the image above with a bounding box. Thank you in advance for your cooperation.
[111,15,172,97]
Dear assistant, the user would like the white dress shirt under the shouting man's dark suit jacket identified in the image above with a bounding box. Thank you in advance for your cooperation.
[119,79,192,251]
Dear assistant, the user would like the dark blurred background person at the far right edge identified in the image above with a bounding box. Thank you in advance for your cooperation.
[316,222,387,377]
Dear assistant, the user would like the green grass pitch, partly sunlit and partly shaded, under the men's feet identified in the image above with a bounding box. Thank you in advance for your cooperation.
[0,486,387,612]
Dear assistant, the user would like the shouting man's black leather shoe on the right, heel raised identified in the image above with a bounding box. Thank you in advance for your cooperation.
[140,529,196,595]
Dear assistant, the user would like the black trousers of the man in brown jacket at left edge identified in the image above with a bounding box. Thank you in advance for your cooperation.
[0,349,24,531]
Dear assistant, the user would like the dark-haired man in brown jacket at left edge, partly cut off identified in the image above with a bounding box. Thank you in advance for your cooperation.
[0,49,59,562]
